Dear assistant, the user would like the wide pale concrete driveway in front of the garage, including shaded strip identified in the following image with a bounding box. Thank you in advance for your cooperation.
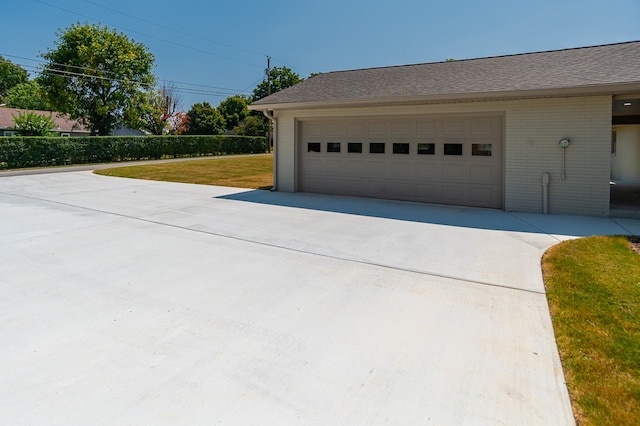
[0,172,640,426]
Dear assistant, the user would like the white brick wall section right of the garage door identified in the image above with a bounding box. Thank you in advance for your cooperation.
[505,97,611,216]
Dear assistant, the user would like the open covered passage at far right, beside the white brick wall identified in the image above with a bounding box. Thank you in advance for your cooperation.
[609,94,640,218]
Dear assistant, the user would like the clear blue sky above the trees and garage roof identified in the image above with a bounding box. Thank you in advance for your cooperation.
[0,0,640,110]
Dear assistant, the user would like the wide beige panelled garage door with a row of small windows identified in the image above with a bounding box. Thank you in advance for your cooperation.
[298,116,503,208]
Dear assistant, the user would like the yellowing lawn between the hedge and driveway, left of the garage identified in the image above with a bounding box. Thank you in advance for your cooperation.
[94,155,273,189]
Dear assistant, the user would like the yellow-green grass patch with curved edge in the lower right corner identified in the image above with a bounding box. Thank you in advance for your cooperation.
[542,237,640,425]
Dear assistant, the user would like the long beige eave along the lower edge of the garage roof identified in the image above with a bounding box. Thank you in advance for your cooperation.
[249,81,640,111]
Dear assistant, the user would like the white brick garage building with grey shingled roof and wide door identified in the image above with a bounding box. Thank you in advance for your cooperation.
[249,42,640,216]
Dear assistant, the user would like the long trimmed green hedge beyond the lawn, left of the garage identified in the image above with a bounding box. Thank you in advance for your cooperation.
[0,135,267,169]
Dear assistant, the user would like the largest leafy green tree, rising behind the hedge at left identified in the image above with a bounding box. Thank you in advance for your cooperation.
[38,24,155,135]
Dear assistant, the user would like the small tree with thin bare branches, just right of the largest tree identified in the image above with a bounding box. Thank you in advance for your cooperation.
[140,84,180,135]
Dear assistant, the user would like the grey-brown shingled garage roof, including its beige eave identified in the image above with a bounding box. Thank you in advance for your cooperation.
[251,41,640,110]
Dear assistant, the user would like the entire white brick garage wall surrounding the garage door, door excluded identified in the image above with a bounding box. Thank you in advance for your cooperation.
[276,96,611,216]
